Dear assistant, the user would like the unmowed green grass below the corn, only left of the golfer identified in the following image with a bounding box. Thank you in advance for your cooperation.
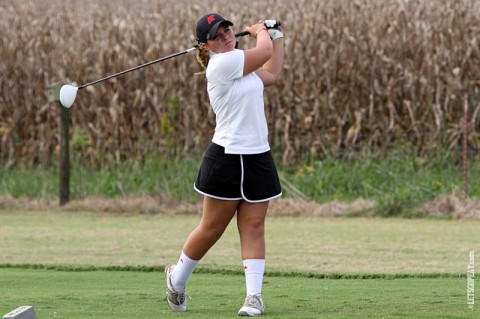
[0,156,200,202]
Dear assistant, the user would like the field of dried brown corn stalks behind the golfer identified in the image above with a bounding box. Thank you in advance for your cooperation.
[0,0,480,165]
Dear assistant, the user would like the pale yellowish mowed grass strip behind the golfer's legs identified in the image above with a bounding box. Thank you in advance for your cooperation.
[0,211,480,276]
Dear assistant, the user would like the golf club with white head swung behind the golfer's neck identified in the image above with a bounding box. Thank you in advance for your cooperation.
[60,20,281,108]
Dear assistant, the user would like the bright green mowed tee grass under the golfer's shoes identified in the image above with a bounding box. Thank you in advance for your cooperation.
[0,268,478,319]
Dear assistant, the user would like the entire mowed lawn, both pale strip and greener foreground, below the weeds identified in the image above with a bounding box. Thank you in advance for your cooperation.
[0,211,480,319]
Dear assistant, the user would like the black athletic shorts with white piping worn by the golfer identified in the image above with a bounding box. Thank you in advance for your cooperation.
[194,143,282,203]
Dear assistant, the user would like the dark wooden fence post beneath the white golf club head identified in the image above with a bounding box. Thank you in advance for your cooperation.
[48,83,70,206]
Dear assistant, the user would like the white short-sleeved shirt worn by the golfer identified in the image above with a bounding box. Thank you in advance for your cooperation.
[207,50,270,154]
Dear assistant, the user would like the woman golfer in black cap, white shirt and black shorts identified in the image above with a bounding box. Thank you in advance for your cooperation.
[165,13,284,316]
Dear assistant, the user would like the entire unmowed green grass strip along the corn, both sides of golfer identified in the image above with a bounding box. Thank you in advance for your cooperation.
[0,148,480,216]
